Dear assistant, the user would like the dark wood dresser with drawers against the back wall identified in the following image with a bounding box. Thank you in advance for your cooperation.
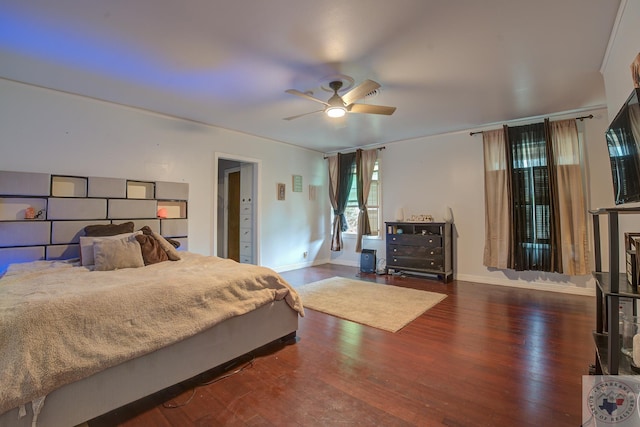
[385,222,453,283]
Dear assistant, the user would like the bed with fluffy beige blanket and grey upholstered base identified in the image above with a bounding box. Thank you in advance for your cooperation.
[0,242,304,426]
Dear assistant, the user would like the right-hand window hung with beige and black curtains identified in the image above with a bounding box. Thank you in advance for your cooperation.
[483,119,590,275]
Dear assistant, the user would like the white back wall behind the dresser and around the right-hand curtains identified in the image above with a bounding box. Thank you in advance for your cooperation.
[332,110,613,294]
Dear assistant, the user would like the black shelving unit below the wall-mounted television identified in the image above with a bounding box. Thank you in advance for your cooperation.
[589,207,640,375]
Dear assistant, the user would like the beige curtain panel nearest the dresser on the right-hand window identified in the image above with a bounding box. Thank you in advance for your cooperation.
[482,129,511,269]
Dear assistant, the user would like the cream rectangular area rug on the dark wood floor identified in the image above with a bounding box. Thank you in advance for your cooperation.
[296,277,446,332]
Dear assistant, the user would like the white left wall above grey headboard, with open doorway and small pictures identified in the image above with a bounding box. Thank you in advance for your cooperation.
[0,79,329,270]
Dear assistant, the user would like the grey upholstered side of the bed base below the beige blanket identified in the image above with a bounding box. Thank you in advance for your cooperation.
[0,300,298,427]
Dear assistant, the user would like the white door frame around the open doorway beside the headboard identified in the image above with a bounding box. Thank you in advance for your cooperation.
[211,152,262,265]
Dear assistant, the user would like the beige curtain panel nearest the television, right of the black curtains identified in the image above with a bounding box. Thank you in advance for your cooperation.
[550,119,590,276]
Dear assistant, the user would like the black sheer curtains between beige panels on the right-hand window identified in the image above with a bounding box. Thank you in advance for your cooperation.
[507,121,562,272]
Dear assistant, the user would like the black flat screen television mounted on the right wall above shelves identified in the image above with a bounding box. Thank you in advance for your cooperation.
[606,88,640,205]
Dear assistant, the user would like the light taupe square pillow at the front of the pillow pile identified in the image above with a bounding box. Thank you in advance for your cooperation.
[93,236,144,271]
